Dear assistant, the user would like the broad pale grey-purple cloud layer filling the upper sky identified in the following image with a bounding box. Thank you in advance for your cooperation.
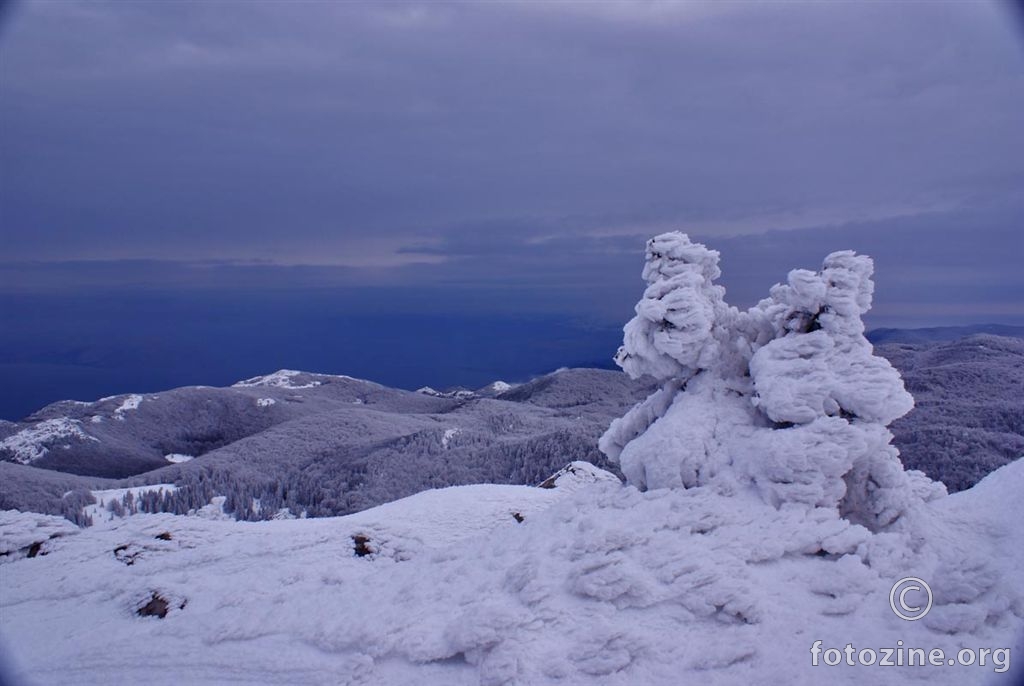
[2,2,1024,260]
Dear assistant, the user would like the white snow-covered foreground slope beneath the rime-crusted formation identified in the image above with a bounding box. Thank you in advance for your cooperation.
[0,461,1024,686]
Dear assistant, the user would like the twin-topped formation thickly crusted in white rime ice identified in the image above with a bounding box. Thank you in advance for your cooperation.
[600,231,945,530]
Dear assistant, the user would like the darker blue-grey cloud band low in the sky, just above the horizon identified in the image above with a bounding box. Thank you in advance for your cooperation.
[6,198,1024,326]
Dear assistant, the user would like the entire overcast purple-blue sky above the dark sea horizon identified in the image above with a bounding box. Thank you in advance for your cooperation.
[0,0,1024,415]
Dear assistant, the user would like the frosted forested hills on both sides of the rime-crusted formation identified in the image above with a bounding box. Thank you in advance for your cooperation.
[0,334,1024,519]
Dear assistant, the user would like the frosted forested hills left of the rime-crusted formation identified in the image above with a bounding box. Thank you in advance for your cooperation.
[0,370,649,519]
